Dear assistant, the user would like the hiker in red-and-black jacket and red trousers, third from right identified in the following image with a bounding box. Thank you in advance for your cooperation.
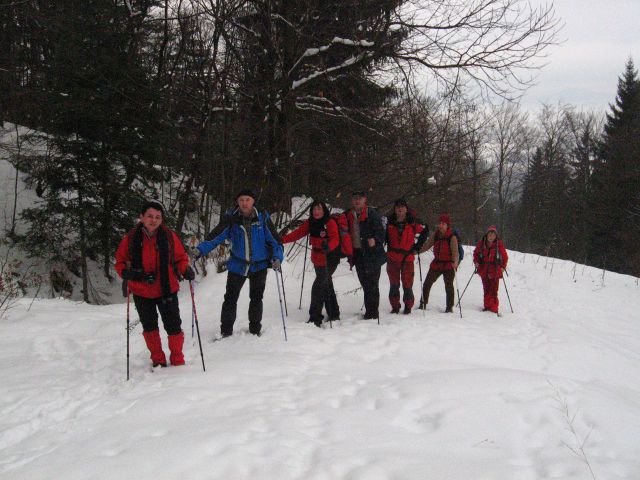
[386,198,429,315]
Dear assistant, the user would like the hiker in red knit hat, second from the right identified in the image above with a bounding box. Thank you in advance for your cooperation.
[419,213,459,313]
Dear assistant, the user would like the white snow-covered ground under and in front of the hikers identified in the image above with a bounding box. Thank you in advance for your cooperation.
[0,250,640,480]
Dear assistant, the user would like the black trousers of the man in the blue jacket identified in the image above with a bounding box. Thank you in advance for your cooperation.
[220,268,269,336]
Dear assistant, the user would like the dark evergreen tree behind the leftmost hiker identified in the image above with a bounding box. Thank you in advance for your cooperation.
[19,0,162,301]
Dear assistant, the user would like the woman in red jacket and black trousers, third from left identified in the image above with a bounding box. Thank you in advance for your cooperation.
[282,201,351,327]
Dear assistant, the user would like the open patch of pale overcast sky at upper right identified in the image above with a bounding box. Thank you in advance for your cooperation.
[522,0,640,110]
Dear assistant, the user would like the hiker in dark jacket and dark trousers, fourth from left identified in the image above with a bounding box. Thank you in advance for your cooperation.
[345,191,387,321]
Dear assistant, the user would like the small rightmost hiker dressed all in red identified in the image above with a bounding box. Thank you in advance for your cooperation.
[473,226,509,313]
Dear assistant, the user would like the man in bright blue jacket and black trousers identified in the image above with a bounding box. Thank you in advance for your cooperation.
[191,190,284,337]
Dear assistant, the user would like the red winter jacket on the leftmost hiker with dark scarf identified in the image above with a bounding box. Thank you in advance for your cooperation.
[116,225,189,298]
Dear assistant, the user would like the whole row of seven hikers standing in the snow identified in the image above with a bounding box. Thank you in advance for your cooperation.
[115,189,508,366]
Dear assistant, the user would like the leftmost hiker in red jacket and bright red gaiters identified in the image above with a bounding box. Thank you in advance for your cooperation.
[115,200,195,367]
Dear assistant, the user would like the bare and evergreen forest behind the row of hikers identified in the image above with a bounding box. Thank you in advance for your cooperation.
[0,0,640,301]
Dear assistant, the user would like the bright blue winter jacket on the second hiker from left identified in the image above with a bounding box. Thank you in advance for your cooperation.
[196,208,284,277]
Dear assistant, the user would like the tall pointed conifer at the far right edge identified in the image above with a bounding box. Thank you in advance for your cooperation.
[589,59,640,273]
